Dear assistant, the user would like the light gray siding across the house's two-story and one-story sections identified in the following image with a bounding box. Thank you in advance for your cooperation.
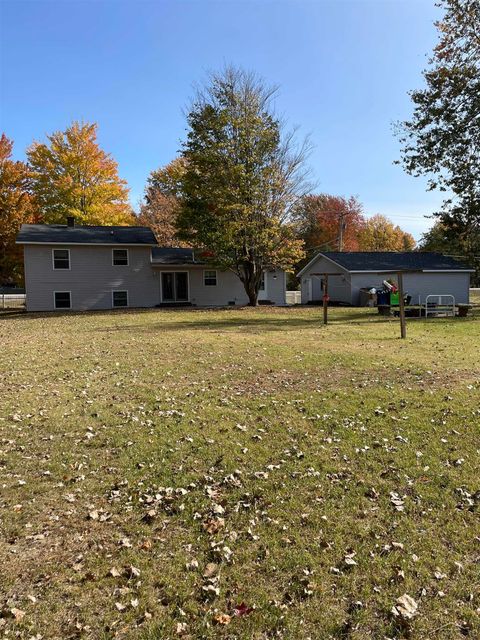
[24,244,285,311]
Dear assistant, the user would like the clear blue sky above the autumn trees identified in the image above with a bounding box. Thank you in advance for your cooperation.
[0,0,442,238]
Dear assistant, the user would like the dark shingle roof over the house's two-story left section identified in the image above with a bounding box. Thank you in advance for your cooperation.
[17,224,157,245]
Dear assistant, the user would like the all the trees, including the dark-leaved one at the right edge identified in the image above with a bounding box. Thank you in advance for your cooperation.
[0,0,480,304]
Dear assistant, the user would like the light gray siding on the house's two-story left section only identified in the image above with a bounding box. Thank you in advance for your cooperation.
[24,245,160,311]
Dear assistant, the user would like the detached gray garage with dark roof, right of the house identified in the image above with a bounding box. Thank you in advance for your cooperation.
[298,251,474,306]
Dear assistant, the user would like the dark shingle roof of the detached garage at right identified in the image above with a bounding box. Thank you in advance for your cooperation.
[319,251,470,271]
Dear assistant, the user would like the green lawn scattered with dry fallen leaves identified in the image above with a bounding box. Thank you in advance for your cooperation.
[0,308,480,640]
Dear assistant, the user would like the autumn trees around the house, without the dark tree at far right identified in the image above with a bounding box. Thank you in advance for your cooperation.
[0,80,415,304]
